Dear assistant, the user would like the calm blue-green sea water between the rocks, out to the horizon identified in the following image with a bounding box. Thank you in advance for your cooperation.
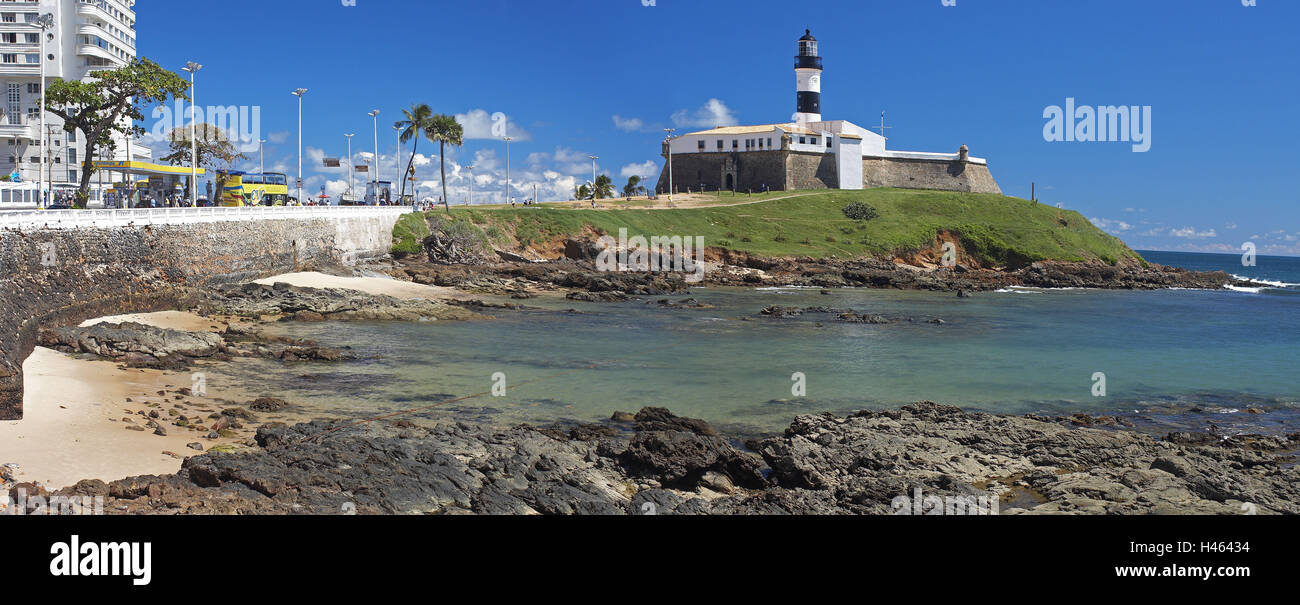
[218,251,1300,432]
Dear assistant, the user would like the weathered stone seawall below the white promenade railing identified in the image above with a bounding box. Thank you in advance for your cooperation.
[0,212,398,420]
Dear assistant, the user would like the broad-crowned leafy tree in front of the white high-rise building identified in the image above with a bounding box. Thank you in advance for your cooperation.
[46,57,190,208]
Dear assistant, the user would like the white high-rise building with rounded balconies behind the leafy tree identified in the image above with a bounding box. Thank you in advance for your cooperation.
[0,0,152,189]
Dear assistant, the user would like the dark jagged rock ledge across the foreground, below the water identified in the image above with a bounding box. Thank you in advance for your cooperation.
[43,402,1300,514]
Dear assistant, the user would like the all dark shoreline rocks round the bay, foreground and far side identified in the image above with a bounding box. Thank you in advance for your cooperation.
[4,245,1300,514]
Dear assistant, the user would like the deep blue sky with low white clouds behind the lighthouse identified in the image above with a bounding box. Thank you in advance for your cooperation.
[137,0,1300,255]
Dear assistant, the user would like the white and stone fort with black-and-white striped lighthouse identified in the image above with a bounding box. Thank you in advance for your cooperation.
[658,31,1002,194]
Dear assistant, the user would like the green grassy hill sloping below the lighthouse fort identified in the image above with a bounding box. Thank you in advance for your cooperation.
[394,189,1140,265]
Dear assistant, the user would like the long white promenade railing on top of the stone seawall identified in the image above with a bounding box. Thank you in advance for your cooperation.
[0,206,411,230]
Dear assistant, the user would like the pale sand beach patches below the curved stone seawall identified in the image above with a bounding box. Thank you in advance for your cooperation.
[0,273,410,488]
